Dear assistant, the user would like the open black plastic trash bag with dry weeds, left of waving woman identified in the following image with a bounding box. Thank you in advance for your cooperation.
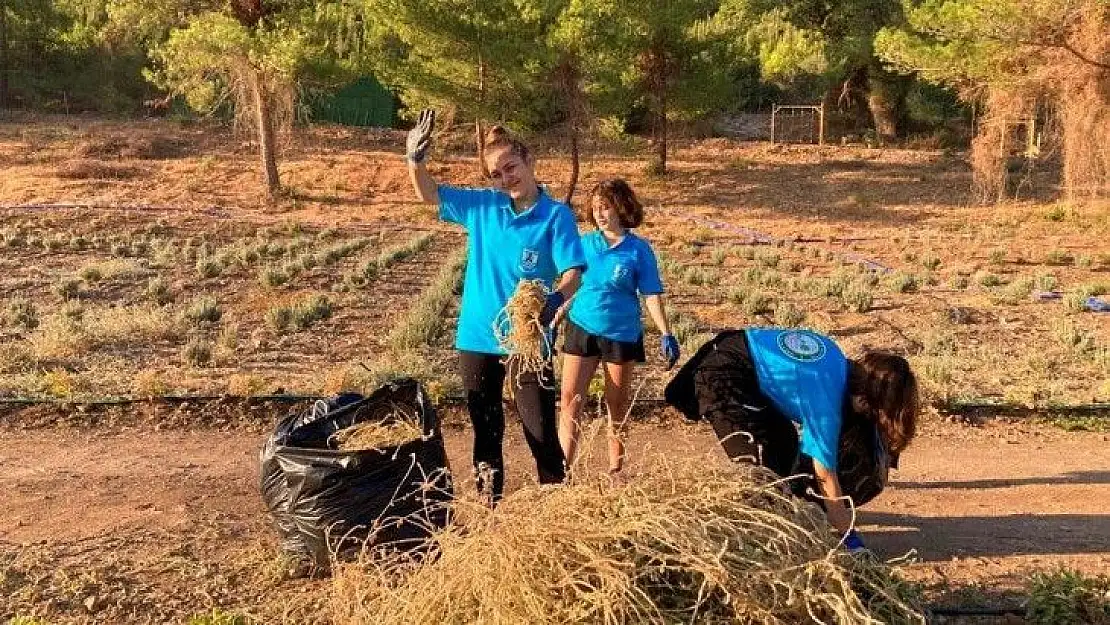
[261,379,453,572]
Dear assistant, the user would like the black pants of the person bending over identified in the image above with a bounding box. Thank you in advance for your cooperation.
[666,331,800,477]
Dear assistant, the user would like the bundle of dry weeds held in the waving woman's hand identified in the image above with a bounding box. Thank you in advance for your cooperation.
[494,280,552,375]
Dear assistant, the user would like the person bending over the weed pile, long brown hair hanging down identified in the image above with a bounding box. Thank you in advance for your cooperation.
[666,327,918,551]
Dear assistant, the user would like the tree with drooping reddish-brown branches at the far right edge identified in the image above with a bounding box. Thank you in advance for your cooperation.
[876,0,1110,199]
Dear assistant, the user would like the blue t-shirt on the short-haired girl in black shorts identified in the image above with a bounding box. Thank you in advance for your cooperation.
[567,230,663,343]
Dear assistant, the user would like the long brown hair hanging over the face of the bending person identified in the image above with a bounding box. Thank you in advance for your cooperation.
[848,351,918,454]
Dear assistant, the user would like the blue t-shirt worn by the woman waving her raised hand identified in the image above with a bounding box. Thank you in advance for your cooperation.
[438,184,586,354]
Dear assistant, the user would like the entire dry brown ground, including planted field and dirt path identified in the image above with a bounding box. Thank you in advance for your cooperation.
[0,115,1110,623]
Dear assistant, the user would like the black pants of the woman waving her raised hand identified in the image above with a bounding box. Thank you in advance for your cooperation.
[458,351,566,501]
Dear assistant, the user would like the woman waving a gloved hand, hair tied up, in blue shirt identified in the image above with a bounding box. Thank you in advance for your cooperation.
[407,110,586,502]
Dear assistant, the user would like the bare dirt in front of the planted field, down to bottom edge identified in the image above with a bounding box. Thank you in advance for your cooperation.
[0,415,1110,623]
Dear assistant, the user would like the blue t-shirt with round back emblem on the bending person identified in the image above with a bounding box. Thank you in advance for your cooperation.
[745,327,848,471]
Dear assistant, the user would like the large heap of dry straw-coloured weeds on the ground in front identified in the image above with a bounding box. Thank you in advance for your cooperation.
[331,458,924,625]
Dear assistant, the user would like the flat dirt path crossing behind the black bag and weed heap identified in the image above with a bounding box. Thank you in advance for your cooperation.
[0,423,1110,614]
